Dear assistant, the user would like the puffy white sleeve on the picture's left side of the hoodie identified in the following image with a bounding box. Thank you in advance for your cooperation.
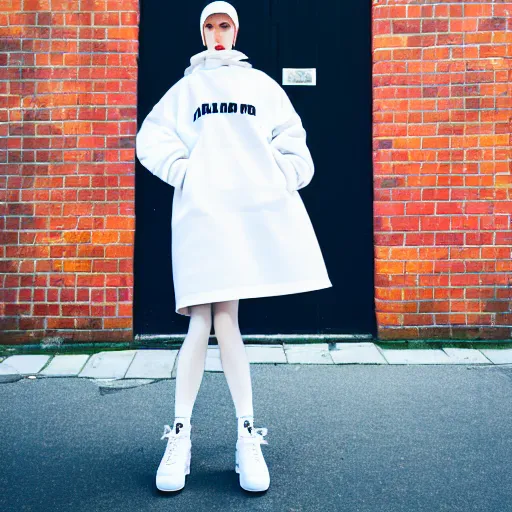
[135,82,189,188]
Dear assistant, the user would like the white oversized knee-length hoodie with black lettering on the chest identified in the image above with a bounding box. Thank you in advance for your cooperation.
[136,50,332,315]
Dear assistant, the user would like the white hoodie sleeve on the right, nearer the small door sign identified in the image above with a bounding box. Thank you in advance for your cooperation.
[270,82,315,192]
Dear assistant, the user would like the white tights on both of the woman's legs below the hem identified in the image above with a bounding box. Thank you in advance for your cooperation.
[174,300,253,417]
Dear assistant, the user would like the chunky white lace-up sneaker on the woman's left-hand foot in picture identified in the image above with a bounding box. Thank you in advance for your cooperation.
[156,423,192,491]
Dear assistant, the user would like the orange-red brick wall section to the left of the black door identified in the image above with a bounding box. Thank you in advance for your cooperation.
[0,0,139,344]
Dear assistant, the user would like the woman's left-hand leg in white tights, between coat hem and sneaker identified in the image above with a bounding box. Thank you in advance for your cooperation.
[174,304,212,418]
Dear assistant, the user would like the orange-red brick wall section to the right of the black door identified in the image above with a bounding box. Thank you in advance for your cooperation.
[372,0,512,339]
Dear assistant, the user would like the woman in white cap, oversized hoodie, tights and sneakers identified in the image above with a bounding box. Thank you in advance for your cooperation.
[136,2,332,491]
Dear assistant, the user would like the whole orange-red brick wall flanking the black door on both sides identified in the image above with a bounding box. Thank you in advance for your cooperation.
[0,0,512,343]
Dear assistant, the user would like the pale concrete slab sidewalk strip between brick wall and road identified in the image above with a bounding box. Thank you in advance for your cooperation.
[0,342,512,382]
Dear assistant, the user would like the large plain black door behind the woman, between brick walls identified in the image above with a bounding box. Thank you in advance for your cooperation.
[134,0,376,335]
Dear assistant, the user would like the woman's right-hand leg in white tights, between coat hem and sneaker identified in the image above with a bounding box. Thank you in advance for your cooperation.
[212,300,253,418]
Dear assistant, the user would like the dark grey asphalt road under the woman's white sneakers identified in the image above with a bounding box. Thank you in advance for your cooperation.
[0,365,512,512]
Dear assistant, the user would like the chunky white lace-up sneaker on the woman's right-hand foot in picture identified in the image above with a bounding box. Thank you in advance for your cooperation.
[235,427,270,492]
